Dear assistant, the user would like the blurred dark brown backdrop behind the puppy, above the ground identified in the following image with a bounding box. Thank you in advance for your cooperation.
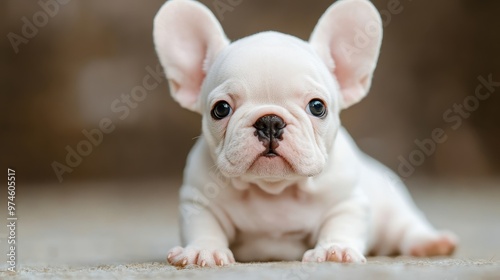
[0,0,500,182]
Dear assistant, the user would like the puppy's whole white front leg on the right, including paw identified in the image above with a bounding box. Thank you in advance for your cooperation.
[302,196,368,263]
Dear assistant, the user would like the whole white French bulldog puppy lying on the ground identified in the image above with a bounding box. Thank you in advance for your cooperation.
[154,0,457,266]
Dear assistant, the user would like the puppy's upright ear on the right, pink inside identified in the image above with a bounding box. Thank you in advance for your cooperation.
[309,0,382,108]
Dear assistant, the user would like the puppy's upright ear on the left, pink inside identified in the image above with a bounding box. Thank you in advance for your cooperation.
[153,0,229,112]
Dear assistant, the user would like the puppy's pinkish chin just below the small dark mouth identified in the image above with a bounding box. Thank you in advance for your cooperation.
[247,156,296,178]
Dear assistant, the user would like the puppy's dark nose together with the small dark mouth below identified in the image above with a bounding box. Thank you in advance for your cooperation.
[253,115,286,157]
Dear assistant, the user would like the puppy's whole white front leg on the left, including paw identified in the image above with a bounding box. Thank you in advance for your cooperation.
[167,202,235,267]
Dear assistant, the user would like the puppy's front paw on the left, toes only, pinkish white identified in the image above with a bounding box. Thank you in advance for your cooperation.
[167,246,235,267]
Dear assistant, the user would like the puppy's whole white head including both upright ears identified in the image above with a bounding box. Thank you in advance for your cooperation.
[154,0,382,180]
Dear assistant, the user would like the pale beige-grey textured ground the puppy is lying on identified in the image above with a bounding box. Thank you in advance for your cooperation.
[0,181,500,280]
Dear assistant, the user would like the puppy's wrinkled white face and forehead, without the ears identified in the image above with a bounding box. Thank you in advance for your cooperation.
[200,34,340,180]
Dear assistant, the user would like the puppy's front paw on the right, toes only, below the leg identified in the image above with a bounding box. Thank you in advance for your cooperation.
[302,244,366,263]
